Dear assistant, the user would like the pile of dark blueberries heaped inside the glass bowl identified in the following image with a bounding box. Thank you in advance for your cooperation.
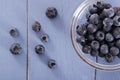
[76,2,120,63]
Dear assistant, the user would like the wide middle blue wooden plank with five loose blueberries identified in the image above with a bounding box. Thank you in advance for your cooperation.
[28,0,94,80]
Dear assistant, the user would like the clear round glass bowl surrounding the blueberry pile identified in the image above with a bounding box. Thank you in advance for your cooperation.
[70,0,120,71]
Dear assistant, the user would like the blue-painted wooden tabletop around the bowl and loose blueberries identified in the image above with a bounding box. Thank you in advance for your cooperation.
[0,0,120,80]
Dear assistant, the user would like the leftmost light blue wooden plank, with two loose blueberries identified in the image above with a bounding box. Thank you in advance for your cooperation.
[0,0,27,80]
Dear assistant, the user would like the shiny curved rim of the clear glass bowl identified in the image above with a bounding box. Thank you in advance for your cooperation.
[70,0,120,71]
